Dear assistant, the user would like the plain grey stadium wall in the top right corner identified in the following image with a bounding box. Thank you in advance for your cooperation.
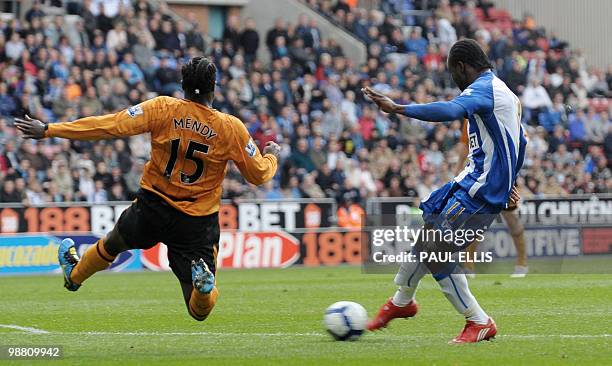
[493,0,612,68]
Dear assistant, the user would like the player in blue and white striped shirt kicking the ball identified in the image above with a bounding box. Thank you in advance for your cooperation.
[363,39,527,343]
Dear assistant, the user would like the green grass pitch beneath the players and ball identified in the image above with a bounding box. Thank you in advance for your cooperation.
[0,267,612,365]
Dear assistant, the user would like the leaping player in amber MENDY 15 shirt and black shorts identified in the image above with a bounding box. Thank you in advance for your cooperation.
[15,57,280,320]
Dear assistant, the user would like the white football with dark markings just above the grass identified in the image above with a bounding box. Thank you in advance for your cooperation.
[323,301,368,341]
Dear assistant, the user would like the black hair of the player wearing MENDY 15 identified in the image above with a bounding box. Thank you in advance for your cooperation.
[181,56,217,96]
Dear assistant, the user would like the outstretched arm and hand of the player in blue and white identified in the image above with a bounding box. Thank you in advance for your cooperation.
[362,88,466,122]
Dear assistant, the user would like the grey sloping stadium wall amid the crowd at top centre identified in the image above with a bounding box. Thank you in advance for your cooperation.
[241,0,367,65]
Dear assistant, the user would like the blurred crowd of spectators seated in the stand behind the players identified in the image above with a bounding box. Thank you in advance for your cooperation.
[0,0,612,204]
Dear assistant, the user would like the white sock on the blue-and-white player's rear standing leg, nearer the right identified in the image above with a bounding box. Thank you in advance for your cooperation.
[438,273,489,324]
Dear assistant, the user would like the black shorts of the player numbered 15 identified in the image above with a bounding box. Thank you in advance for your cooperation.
[116,189,220,283]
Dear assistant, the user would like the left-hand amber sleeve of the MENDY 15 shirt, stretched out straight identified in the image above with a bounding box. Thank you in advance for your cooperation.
[45,98,163,140]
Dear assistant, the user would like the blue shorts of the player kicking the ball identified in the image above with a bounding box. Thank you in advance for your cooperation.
[419,181,500,250]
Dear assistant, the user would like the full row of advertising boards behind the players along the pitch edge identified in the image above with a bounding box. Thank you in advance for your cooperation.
[0,196,612,274]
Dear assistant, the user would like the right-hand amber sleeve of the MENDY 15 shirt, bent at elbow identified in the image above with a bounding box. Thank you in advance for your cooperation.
[229,116,278,185]
